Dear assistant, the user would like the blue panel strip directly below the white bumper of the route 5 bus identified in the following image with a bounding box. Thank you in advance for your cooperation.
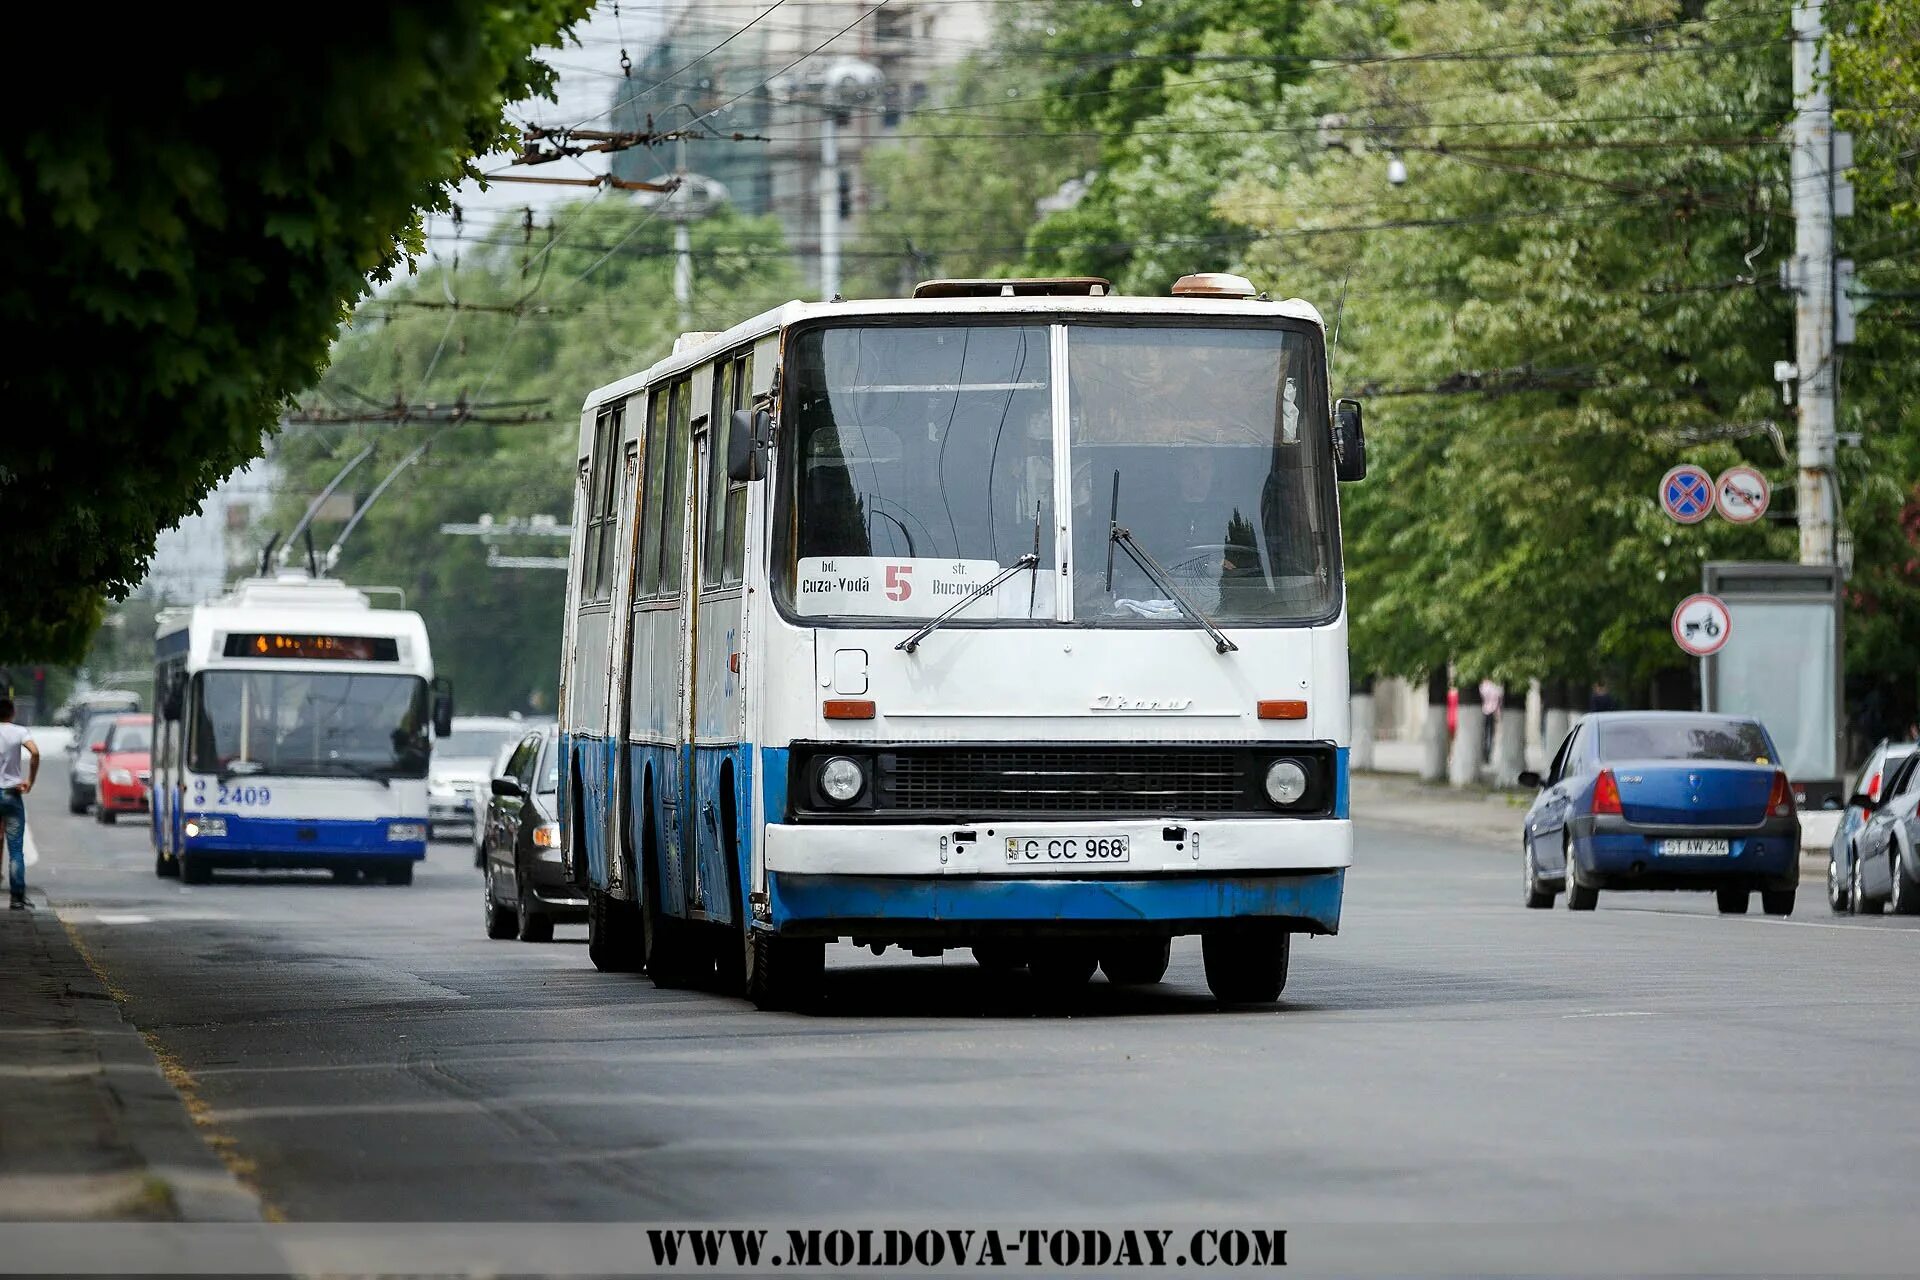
[766,869,1346,936]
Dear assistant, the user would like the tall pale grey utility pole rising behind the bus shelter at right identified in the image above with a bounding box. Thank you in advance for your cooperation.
[1791,0,1851,564]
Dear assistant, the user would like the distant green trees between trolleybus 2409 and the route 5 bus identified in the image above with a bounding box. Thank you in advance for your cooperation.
[271,205,799,714]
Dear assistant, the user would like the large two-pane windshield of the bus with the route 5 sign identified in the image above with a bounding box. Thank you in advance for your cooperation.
[778,322,1338,628]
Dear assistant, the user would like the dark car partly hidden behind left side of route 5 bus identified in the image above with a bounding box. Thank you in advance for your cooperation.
[480,727,588,942]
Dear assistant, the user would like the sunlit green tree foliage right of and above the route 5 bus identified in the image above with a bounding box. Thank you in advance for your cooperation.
[860,0,1920,710]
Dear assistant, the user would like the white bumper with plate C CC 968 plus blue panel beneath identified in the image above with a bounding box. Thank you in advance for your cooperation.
[766,818,1354,938]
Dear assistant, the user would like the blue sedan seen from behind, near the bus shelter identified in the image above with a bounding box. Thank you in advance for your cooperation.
[1521,712,1799,915]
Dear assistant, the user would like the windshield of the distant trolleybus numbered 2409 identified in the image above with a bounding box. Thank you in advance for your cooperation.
[188,670,428,777]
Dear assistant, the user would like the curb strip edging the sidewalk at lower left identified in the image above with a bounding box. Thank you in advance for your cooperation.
[33,894,265,1222]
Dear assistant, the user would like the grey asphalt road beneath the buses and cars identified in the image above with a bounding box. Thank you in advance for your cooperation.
[15,762,1920,1251]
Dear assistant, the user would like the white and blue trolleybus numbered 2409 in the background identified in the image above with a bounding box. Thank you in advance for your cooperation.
[154,572,453,885]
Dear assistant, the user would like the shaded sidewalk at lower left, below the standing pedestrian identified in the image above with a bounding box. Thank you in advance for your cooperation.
[0,892,259,1222]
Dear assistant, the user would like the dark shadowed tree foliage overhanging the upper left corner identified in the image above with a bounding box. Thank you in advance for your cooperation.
[0,0,588,658]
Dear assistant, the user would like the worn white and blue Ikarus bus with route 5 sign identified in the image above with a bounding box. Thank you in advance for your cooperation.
[561,274,1365,1007]
